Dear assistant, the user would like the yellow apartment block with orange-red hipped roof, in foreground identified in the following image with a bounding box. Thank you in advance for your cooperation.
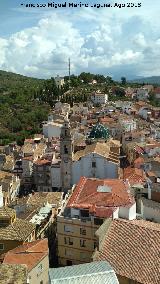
[57,177,136,266]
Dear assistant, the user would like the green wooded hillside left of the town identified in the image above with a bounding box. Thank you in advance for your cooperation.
[0,71,50,145]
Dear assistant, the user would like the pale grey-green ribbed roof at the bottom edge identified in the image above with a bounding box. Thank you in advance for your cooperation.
[49,261,119,284]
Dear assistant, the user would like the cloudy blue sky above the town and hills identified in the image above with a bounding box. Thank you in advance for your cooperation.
[0,0,160,79]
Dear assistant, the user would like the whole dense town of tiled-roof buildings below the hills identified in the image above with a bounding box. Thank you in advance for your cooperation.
[0,76,160,284]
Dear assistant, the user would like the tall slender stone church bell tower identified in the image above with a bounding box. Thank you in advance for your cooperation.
[60,118,73,192]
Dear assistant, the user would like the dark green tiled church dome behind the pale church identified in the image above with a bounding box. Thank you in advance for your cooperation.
[89,123,110,139]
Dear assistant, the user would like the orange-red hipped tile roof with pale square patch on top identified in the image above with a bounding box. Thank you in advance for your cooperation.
[67,177,134,217]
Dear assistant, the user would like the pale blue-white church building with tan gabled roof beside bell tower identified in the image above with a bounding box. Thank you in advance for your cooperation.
[72,143,119,184]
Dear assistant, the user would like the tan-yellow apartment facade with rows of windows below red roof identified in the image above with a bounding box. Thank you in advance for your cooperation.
[57,216,103,266]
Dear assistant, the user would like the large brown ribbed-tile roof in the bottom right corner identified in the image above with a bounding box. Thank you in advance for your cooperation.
[98,219,160,284]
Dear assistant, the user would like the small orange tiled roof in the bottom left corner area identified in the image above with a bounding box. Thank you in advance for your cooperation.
[3,239,48,270]
